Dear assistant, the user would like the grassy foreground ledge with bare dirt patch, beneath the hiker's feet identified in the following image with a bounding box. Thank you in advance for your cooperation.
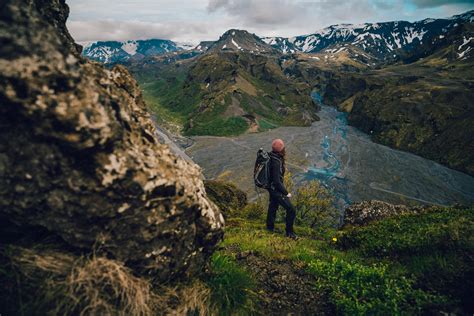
[206,180,474,315]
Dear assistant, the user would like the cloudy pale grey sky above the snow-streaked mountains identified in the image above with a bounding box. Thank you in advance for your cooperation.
[66,0,474,44]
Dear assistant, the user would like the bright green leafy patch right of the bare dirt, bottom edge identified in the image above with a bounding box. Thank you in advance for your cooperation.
[309,258,435,315]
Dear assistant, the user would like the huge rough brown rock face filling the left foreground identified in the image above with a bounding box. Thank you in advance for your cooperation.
[0,0,223,280]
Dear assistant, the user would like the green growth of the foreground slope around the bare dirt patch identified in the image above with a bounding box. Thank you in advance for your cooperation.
[210,209,474,314]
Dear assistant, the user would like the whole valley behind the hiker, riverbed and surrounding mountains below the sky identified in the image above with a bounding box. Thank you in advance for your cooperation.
[86,11,474,204]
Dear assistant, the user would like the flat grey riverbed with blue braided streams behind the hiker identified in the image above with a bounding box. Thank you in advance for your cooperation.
[186,92,474,209]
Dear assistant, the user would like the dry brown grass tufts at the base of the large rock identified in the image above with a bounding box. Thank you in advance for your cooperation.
[1,247,214,315]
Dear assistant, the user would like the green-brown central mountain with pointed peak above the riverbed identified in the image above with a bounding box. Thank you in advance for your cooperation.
[127,30,318,136]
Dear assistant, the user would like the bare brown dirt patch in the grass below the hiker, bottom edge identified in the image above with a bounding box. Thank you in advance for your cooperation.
[236,252,334,315]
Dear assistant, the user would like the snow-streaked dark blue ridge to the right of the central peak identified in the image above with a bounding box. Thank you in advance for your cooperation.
[263,10,474,60]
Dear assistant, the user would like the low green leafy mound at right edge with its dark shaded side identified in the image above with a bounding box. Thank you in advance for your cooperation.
[337,208,474,311]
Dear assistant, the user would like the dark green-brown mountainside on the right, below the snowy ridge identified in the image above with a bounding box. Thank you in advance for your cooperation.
[294,22,474,175]
